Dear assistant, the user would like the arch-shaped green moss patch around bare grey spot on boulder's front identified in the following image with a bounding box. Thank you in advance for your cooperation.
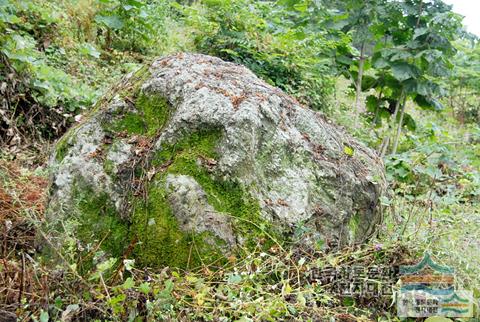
[124,129,278,268]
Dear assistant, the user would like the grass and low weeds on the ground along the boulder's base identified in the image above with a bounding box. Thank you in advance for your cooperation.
[0,130,479,321]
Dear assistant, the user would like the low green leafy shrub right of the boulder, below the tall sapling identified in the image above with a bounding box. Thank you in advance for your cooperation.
[386,120,480,203]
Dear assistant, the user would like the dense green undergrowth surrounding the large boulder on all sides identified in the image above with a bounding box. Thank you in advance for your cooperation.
[0,0,480,321]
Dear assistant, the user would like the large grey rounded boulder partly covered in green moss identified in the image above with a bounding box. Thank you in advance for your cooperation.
[47,54,385,267]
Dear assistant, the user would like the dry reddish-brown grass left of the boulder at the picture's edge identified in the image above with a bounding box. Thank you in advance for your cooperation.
[0,160,48,312]
